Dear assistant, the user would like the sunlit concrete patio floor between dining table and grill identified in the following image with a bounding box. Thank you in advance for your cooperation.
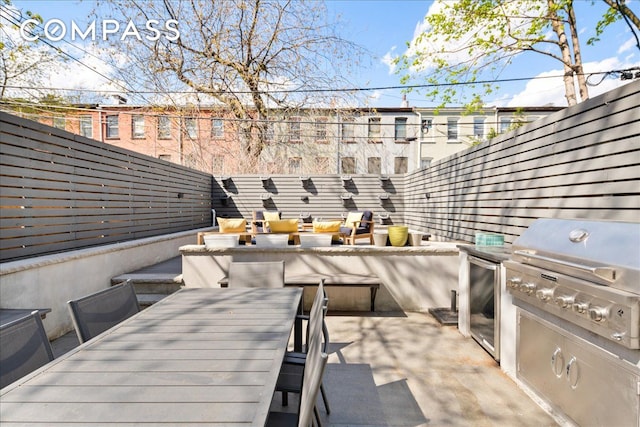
[53,313,559,427]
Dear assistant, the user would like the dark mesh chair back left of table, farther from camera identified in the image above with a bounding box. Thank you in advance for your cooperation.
[68,280,140,343]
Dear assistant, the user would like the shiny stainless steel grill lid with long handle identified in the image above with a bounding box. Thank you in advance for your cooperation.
[512,218,640,294]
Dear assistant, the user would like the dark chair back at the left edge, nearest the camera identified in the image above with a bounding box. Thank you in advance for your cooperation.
[0,310,53,388]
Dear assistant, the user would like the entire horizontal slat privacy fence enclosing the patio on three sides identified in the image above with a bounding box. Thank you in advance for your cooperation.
[0,81,640,260]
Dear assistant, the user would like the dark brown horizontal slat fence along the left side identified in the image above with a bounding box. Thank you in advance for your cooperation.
[0,113,212,261]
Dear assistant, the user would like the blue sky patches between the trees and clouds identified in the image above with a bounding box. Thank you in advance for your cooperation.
[6,0,640,107]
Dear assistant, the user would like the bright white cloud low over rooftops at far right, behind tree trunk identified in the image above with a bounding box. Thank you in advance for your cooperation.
[504,57,633,107]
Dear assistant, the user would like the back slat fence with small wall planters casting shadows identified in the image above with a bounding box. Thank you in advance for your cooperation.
[213,175,405,224]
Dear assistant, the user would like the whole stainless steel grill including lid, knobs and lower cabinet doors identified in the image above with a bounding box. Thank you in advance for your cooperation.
[504,219,640,427]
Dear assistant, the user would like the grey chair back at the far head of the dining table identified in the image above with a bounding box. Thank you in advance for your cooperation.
[228,261,284,288]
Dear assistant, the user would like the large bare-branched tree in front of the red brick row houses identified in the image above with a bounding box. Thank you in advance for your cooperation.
[95,0,361,169]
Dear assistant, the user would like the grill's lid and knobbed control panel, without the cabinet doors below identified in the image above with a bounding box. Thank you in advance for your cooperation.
[505,219,640,349]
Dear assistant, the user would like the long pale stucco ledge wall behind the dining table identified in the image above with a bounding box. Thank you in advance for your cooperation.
[180,242,460,311]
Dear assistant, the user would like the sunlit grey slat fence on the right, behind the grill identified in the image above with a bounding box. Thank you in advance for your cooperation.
[404,81,640,243]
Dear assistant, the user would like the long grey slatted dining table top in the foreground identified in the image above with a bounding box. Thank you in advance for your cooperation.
[0,288,302,426]
